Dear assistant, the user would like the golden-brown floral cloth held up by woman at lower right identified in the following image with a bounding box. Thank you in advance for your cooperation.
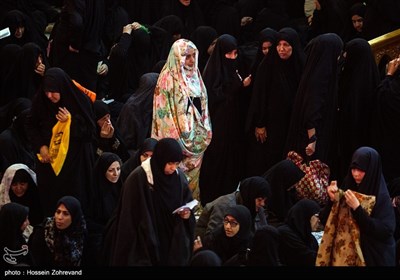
[315,191,376,266]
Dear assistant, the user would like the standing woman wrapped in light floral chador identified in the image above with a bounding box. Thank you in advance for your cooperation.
[151,39,211,201]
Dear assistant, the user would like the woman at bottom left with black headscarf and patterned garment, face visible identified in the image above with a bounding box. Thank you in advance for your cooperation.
[29,196,86,267]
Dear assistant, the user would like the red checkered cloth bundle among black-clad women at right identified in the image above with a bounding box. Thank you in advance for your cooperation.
[287,151,330,205]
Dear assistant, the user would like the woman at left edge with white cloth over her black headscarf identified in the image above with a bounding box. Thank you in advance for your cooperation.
[0,163,44,225]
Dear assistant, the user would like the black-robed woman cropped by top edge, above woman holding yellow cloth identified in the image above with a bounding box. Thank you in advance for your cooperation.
[49,0,106,91]
